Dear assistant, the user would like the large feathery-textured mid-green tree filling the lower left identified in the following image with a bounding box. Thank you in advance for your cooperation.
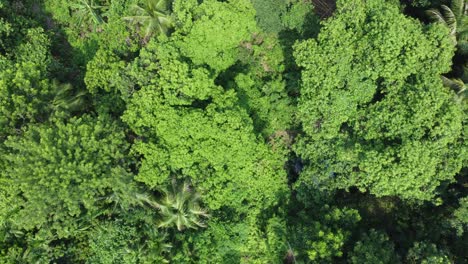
[0,115,135,261]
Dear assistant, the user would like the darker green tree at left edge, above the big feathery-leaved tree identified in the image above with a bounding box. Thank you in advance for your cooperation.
[0,28,53,137]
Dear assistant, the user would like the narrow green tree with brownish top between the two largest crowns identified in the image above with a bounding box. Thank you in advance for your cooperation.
[234,34,293,137]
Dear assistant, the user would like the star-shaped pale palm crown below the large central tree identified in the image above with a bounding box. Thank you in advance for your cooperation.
[137,180,209,231]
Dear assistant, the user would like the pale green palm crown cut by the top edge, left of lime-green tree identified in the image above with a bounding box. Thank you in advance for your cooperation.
[123,0,172,42]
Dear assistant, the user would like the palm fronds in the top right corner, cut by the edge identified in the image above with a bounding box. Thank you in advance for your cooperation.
[427,0,468,55]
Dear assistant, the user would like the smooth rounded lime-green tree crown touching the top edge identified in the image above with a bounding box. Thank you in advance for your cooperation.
[178,0,258,73]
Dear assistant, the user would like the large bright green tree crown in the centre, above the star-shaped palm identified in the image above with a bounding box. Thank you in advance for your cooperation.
[123,37,286,212]
